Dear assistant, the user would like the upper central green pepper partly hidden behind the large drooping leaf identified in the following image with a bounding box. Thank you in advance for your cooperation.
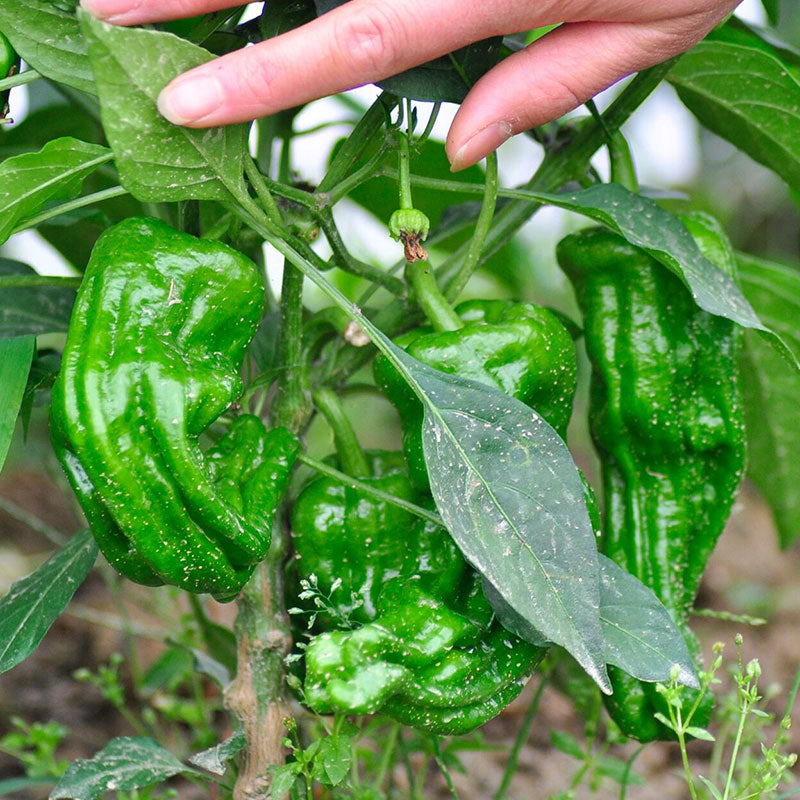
[373,300,577,489]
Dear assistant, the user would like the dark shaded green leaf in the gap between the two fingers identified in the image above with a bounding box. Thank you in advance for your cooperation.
[314,0,503,103]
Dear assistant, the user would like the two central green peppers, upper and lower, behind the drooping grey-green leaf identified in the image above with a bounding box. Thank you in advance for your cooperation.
[292,294,576,734]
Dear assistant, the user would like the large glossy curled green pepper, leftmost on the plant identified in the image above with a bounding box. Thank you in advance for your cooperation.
[51,219,298,601]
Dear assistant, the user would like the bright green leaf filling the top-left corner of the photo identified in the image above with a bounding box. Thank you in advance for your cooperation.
[0,0,95,94]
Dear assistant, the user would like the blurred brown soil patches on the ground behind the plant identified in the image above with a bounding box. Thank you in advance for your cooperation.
[0,466,800,800]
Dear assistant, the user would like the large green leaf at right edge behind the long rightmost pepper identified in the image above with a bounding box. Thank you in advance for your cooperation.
[737,253,800,547]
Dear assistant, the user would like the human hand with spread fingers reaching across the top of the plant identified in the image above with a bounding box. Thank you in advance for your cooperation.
[81,0,739,169]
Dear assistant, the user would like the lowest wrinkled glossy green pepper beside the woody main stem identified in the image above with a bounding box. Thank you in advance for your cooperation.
[292,452,544,734]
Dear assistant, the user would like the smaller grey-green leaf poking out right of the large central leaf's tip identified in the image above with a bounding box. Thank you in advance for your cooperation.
[600,555,700,689]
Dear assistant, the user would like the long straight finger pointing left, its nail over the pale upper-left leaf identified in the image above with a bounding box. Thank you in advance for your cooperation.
[159,0,557,127]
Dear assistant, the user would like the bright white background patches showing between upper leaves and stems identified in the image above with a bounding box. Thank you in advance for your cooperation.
[3,0,765,294]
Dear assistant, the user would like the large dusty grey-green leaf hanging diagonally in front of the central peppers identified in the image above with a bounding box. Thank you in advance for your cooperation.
[388,344,610,691]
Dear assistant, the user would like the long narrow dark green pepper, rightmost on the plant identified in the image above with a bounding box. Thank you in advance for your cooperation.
[558,214,745,741]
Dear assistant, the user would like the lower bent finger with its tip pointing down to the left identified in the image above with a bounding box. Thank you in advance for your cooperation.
[446,19,713,170]
